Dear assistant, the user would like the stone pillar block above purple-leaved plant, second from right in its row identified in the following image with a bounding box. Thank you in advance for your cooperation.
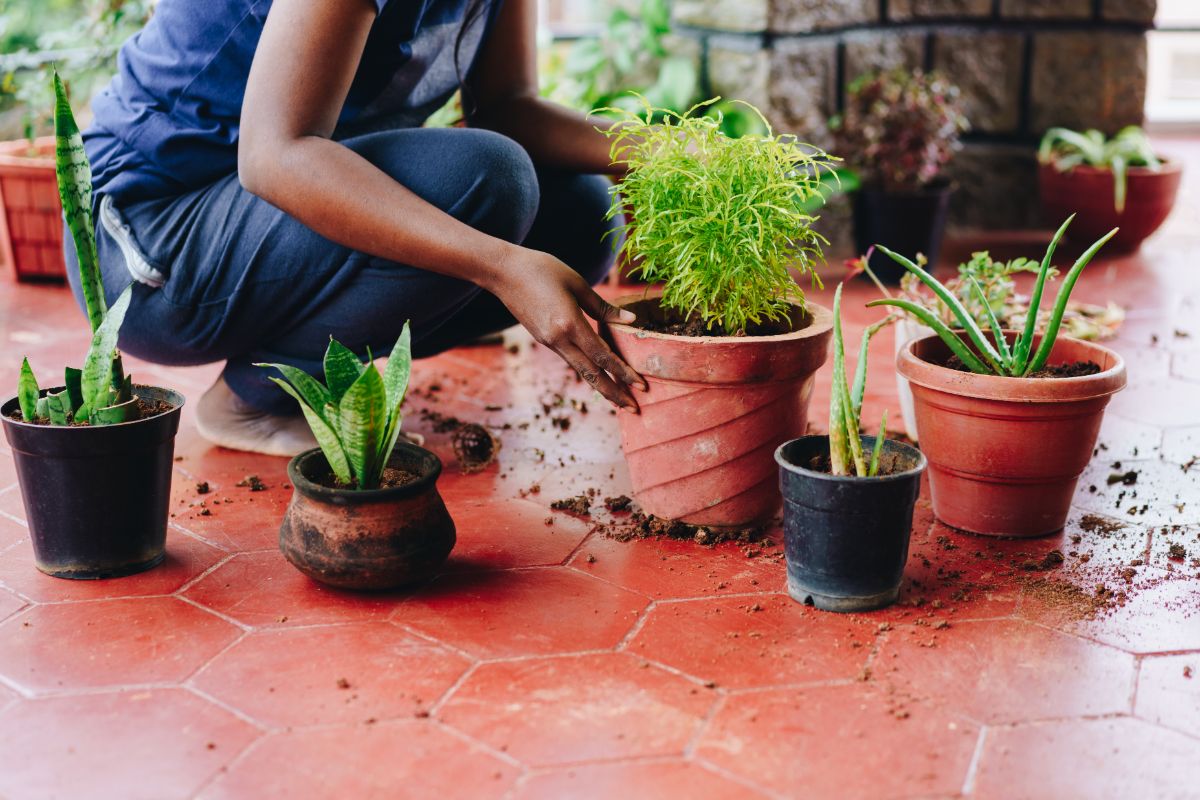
[934,31,1022,133]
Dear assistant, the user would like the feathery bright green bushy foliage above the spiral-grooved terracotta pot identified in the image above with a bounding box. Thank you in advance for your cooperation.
[607,98,836,335]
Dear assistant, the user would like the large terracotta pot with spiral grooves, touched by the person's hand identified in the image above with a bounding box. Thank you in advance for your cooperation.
[607,293,832,527]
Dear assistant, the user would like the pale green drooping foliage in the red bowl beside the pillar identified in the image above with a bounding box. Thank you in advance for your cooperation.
[1038,125,1163,212]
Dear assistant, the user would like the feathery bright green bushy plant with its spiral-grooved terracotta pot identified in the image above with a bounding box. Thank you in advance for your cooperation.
[597,101,834,525]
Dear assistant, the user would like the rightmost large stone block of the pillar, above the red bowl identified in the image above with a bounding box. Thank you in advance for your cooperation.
[1030,31,1146,136]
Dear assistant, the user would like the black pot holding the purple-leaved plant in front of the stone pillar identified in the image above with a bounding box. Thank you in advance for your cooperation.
[854,181,954,283]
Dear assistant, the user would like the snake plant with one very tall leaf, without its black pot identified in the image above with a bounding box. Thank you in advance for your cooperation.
[17,72,138,425]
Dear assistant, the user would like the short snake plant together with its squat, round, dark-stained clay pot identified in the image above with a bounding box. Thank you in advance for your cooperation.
[259,324,455,589]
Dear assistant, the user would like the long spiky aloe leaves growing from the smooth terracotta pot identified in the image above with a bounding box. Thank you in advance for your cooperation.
[866,215,1118,378]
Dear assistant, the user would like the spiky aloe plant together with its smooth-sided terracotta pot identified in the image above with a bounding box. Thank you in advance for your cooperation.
[868,218,1126,536]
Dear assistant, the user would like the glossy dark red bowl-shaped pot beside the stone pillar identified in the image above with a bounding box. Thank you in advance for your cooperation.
[1038,161,1183,253]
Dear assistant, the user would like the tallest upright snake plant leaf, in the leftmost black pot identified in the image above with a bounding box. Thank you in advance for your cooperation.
[54,71,106,331]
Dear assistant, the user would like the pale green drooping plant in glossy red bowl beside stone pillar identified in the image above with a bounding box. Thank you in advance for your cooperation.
[1038,126,1183,252]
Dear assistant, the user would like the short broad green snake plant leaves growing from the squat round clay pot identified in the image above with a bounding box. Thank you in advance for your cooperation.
[257,323,413,489]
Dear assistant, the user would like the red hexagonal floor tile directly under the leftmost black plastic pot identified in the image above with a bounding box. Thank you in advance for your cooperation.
[0,530,228,603]
